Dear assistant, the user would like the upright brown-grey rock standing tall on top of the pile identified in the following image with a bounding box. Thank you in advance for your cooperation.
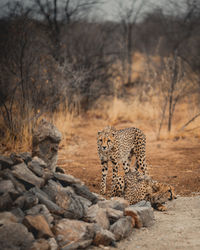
[32,119,62,171]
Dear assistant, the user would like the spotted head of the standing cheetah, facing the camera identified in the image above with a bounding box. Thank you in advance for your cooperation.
[97,126,116,153]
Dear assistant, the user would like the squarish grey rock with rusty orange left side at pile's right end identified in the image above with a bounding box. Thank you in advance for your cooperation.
[124,206,154,228]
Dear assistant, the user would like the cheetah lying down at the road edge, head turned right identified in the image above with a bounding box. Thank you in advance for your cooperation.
[111,171,176,211]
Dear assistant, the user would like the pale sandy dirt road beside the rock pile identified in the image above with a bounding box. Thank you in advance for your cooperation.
[107,196,200,250]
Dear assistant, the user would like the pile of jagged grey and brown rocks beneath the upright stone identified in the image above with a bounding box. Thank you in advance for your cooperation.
[0,120,154,250]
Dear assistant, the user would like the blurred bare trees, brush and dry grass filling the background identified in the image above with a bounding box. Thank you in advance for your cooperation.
[0,0,200,149]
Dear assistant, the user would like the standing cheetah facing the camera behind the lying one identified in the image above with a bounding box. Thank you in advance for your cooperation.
[97,126,147,194]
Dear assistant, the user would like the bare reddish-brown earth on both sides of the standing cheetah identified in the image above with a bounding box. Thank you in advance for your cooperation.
[58,118,200,196]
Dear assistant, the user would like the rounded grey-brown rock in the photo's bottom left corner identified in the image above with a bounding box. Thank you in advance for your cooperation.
[0,222,34,250]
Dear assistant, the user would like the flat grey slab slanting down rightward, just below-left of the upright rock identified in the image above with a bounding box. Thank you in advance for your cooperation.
[12,163,44,188]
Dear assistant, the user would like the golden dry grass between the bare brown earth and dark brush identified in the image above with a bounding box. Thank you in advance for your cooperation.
[0,53,200,153]
